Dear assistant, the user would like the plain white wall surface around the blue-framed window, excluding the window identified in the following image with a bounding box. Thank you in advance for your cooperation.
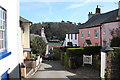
[0,0,20,76]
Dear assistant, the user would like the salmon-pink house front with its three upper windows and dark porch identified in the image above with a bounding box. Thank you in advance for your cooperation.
[78,26,101,47]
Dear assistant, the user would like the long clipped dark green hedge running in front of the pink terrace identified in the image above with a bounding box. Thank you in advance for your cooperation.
[61,46,101,68]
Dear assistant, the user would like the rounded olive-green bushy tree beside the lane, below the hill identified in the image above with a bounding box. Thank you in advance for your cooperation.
[31,37,46,55]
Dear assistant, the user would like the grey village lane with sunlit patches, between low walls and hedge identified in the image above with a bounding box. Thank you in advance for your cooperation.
[29,61,77,80]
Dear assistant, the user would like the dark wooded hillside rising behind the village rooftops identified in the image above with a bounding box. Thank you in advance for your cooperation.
[31,21,77,41]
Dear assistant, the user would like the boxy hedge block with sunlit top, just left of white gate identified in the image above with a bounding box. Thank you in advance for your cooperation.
[64,48,83,68]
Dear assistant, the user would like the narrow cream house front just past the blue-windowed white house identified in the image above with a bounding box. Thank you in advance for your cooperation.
[20,16,32,59]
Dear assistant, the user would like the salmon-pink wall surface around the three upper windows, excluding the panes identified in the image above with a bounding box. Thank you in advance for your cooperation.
[78,26,101,47]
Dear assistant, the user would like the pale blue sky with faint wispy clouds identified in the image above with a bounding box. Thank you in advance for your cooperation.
[20,0,119,23]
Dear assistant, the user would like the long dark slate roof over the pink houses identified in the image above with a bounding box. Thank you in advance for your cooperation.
[79,9,119,29]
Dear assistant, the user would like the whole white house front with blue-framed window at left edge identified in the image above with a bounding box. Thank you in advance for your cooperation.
[0,0,21,80]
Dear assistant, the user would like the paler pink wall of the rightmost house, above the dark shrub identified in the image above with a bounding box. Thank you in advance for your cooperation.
[101,22,120,47]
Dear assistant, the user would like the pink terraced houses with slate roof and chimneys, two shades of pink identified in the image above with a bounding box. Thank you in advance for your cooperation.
[78,6,120,47]
